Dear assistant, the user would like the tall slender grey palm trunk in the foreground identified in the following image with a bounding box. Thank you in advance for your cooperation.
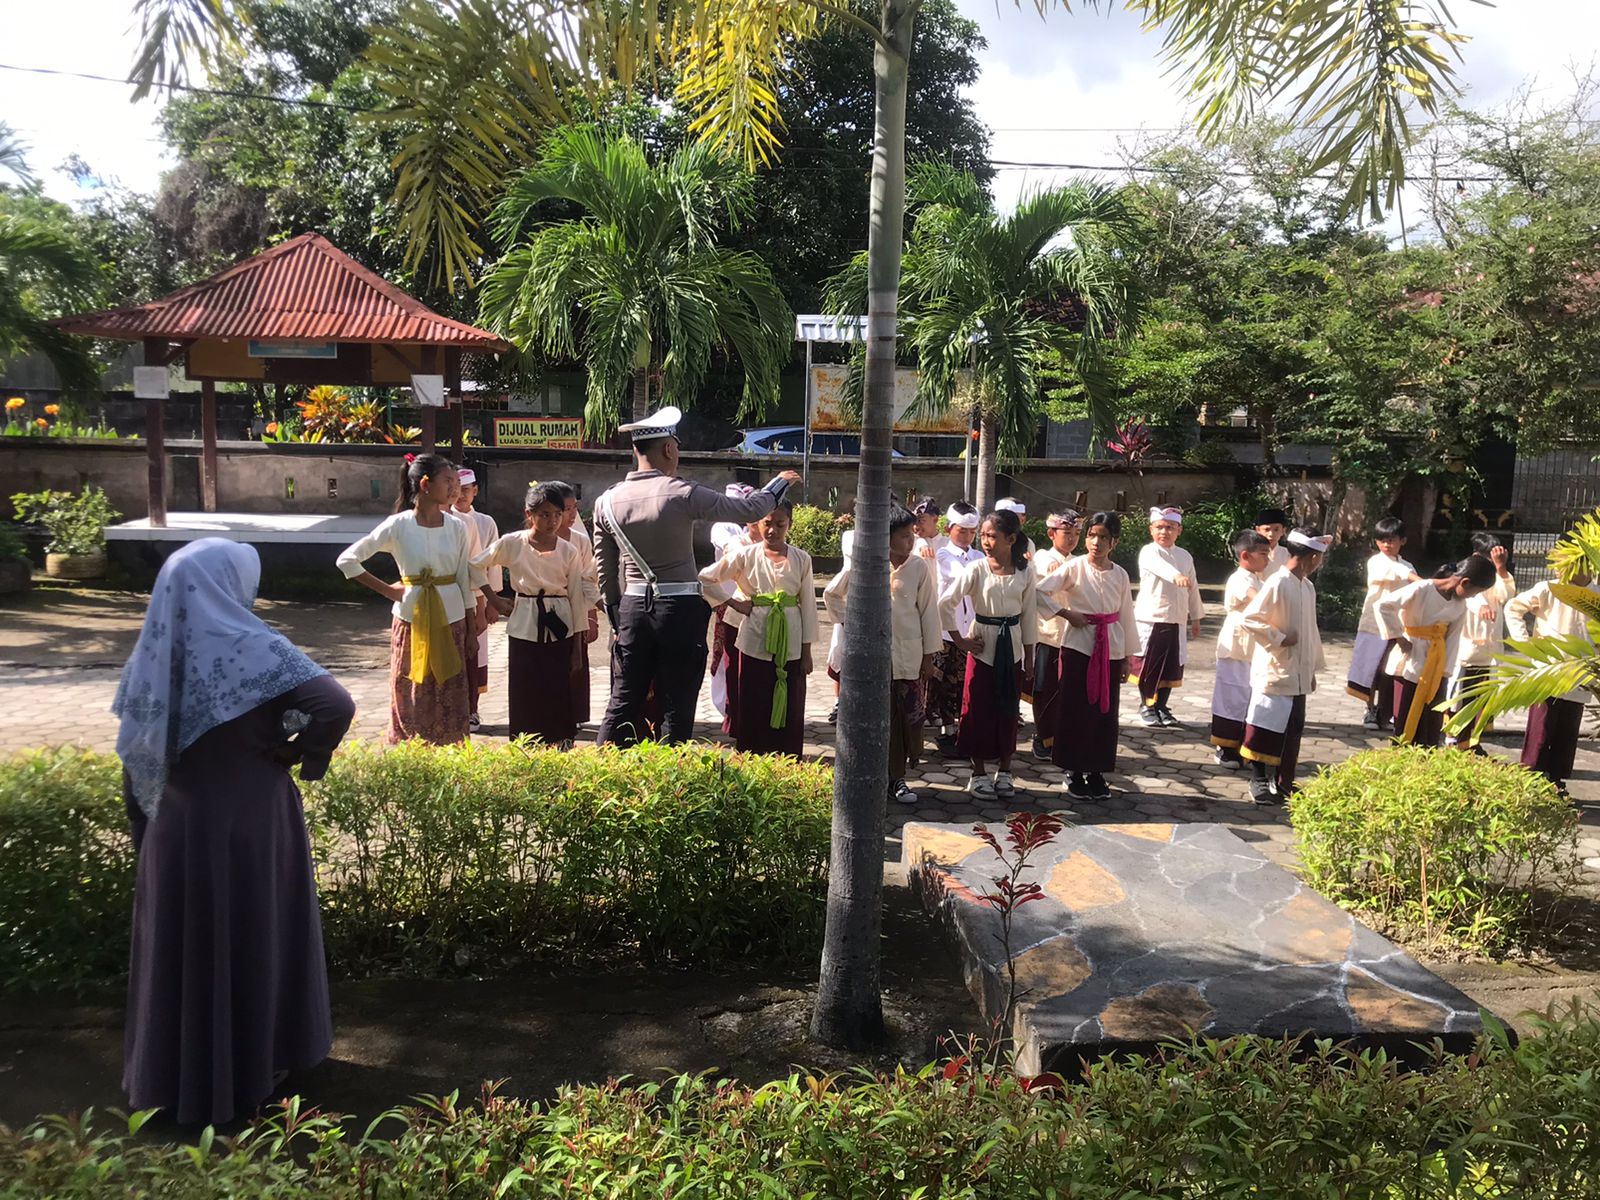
[811,0,918,1050]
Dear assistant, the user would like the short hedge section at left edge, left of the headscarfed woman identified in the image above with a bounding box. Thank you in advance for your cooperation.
[0,749,134,987]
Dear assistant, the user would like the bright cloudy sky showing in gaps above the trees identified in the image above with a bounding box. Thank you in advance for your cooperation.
[0,0,1600,227]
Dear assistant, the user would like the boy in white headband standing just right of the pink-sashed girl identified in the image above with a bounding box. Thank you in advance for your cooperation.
[1128,507,1205,728]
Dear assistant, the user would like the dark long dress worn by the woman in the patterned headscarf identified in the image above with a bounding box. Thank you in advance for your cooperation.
[122,675,355,1125]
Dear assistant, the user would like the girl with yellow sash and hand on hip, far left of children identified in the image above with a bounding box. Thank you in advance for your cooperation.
[338,454,483,746]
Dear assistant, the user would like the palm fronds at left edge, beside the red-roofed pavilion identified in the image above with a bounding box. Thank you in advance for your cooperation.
[0,213,99,390]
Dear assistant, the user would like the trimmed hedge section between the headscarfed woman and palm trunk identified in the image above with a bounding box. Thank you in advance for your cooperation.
[306,742,832,973]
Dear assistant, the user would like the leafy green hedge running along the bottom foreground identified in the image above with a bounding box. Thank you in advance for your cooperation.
[0,1016,1600,1200]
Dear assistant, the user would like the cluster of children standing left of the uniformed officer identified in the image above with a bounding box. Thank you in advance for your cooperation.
[338,454,600,746]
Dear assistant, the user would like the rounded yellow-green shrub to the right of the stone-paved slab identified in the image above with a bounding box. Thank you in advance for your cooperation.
[1290,746,1578,954]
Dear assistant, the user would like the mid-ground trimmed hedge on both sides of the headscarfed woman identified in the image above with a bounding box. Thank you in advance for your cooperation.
[0,742,832,992]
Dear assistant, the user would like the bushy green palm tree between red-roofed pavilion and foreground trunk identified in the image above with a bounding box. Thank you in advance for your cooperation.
[482,126,794,437]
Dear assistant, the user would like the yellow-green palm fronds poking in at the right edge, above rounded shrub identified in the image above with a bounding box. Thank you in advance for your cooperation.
[1448,509,1600,733]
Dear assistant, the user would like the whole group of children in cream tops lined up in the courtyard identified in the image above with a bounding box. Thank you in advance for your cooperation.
[338,454,1590,803]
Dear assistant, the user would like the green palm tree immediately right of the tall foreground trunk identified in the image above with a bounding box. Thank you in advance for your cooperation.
[827,163,1144,510]
